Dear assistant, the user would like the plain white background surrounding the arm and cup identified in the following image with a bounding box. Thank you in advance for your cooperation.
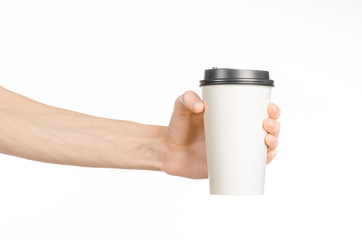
[0,0,362,240]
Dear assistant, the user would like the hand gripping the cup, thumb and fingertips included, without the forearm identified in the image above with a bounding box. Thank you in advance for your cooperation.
[162,91,280,179]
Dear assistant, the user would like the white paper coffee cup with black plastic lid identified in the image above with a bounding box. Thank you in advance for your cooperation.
[200,68,274,195]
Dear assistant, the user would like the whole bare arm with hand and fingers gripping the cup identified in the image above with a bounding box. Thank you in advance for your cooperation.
[0,87,280,179]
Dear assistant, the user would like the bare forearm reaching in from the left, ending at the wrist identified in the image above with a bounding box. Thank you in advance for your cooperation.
[0,87,166,170]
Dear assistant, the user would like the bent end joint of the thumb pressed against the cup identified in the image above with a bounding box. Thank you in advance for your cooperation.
[175,90,205,113]
